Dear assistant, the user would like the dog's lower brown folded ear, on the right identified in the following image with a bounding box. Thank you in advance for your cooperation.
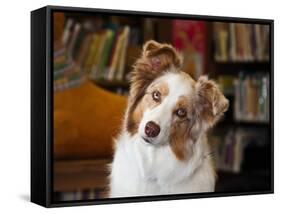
[195,76,229,129]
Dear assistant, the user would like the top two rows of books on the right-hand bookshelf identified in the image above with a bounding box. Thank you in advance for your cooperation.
[207,22,271,123]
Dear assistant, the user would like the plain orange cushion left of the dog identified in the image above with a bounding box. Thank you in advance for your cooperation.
[54,82,127,159]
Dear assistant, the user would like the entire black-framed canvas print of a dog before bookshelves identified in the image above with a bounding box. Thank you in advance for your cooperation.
[31,6,274,207]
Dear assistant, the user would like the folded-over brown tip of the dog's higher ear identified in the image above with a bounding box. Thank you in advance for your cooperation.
[142,40,182,72]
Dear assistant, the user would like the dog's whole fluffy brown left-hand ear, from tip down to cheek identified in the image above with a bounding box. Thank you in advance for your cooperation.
[126,40,182,133]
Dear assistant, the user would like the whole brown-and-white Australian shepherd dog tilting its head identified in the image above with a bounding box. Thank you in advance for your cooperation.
[110,41,229,197]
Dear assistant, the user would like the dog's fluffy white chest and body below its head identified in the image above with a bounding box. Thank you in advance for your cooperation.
[110,133,215,197]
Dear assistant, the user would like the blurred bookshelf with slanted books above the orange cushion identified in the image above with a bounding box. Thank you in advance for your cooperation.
[54,13,173,94]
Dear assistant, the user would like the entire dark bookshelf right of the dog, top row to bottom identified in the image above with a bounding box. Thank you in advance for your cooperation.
[206,20,271,192]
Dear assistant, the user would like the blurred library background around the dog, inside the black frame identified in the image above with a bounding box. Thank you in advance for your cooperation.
[53,12,271,201]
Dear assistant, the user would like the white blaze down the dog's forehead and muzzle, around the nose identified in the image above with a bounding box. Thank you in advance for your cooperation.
[138,72,194,145]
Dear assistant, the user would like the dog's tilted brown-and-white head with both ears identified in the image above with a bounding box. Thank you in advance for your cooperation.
[125,41,228,160]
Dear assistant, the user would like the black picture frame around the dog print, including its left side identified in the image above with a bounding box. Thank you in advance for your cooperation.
[31,6,274,207]
